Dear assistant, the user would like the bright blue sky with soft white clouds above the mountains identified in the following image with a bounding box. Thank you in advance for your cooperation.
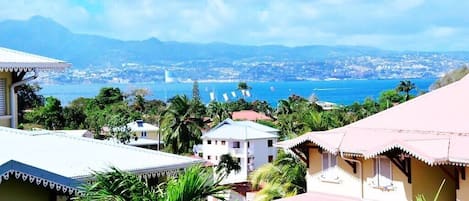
[0,0,469,51]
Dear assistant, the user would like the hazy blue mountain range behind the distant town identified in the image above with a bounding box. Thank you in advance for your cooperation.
[0,16,392,68]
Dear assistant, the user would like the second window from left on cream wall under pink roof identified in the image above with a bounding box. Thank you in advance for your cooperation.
[373,157,392,188]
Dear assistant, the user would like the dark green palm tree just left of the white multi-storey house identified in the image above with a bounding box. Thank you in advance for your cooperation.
[161,95,205,154]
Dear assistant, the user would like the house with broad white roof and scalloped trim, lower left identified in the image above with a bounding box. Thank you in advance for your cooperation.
[0,127,202,201]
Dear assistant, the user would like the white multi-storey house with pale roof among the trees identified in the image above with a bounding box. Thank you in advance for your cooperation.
[201,119,278,183]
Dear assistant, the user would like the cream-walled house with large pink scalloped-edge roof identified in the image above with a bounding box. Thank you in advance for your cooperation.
[277,76,469,201]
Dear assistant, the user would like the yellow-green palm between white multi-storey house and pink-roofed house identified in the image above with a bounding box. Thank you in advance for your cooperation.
[250,152,306,200]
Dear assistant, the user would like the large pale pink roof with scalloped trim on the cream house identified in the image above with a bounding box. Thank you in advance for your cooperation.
[279,76,469,165]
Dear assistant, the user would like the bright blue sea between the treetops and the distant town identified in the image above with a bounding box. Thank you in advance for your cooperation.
[39,78,436,106]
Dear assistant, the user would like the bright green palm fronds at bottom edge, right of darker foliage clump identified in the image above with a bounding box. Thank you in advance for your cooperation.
[159,166,230,201]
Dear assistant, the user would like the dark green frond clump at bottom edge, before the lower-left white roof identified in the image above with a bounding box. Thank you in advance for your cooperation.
[75,167,157,201]
